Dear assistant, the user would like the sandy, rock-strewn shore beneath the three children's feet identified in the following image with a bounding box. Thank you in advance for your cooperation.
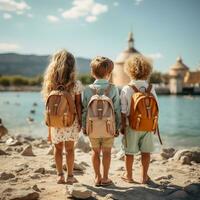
[0,136,200,200]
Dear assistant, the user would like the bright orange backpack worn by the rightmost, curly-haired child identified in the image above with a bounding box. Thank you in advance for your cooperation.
[129,84,162,144]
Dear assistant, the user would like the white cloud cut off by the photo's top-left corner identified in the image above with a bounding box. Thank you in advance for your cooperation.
[0,0,31,13]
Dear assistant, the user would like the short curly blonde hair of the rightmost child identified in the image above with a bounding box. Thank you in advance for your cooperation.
[124,54,153,80]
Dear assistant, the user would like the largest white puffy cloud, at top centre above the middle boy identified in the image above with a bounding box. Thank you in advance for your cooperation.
[62,0,108,22]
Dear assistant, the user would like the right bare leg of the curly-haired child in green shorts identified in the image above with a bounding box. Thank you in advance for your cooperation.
[141,153,150,184]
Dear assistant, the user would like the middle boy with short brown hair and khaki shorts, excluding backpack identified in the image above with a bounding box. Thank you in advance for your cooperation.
[82,56,121,186]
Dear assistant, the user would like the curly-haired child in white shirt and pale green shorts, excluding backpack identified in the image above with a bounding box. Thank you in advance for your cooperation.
[120,54,157,184]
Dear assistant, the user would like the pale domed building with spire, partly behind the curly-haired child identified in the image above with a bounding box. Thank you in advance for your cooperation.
[112,32,140,86]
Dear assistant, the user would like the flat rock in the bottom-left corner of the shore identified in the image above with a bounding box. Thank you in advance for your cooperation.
[2,189,39,200]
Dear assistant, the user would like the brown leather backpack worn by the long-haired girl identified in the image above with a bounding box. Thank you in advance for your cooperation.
[45,85,76,140]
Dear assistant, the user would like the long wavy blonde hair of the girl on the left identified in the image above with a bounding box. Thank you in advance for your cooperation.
[41,49,76,100]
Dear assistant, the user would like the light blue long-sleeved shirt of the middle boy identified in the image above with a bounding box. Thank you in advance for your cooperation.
[82,79,121,130]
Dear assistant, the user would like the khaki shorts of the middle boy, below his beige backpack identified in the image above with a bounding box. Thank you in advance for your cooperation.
[90,137,114,148]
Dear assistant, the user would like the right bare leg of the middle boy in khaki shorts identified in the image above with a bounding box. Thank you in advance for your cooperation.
[102,148,111,182]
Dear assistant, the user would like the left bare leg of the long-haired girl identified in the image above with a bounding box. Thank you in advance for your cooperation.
[54,142,64,183]
